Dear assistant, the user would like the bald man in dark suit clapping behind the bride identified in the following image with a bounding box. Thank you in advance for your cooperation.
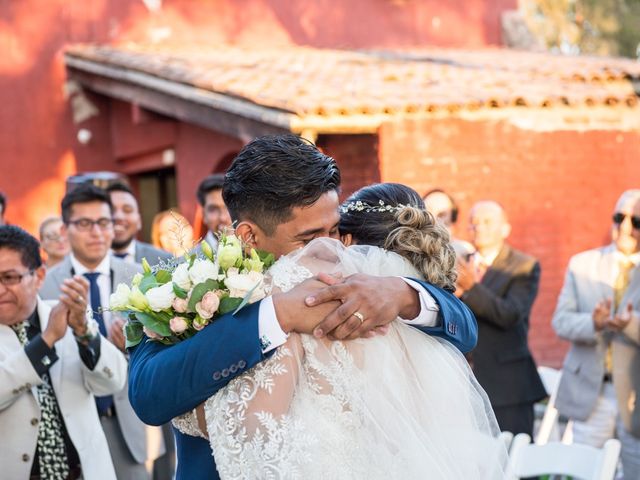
[456,201,547,435]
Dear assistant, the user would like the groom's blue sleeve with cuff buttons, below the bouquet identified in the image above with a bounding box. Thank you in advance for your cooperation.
[129,302,264,425]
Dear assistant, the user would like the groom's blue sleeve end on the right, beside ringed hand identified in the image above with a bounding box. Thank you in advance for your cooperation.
[412,278,478,353]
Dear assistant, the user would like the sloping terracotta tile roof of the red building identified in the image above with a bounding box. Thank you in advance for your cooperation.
[67,45,640,117]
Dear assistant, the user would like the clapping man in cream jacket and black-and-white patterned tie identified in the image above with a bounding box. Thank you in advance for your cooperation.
[0,225,127,480]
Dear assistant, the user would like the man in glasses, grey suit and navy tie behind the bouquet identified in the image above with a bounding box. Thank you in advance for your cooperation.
[40,184,164,480]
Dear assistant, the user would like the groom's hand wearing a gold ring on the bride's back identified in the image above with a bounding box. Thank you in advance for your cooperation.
[306,274,420,340]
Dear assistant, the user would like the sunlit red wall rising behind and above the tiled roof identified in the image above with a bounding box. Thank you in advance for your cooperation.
[0,0,517,236]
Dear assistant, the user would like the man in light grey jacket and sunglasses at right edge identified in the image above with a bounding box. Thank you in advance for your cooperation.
[552,190,640,480]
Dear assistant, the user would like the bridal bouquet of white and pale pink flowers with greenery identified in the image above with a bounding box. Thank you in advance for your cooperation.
[109,235,274,348]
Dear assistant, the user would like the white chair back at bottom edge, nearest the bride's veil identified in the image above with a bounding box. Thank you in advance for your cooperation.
[507,433,620,480]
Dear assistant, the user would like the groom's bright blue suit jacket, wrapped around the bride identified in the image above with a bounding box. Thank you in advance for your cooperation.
[129,280,478,480]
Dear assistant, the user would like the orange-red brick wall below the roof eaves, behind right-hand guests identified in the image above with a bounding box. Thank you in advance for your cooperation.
[379,119,640,366]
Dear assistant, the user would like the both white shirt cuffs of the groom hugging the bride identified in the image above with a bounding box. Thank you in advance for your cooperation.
[258,277,440,353]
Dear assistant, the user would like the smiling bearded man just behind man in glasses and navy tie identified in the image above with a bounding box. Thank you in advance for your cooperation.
[106,183,172,265]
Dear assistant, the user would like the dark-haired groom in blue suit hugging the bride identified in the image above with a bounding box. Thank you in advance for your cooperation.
[129,135,477,480]
